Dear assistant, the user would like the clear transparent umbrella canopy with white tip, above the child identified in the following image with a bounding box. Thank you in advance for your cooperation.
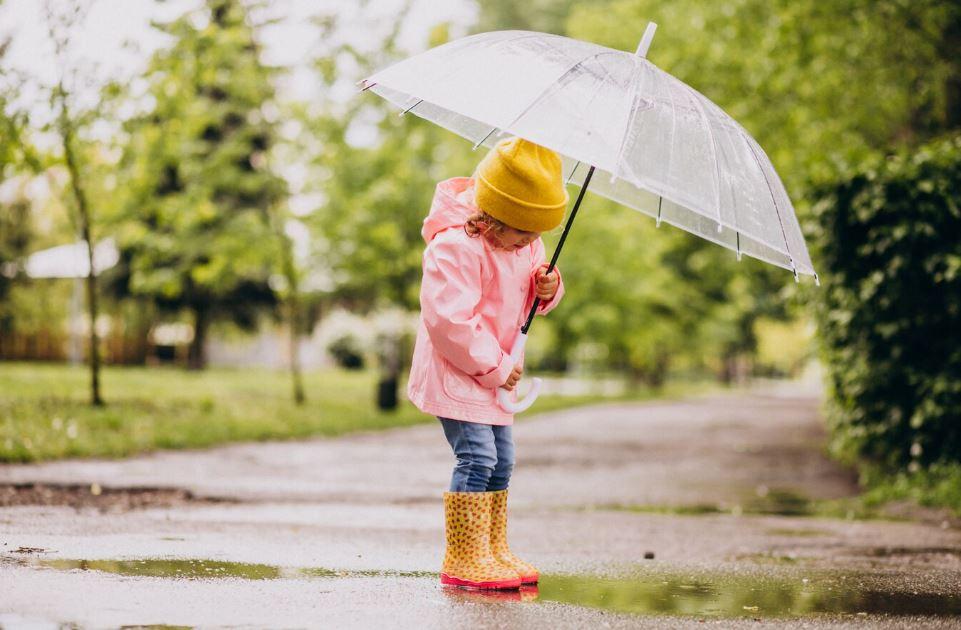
[362,25,817,278]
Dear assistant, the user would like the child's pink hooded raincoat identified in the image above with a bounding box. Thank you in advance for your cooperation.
[407,177,564,425]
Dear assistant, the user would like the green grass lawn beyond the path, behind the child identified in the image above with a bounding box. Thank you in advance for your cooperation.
[0,363,695,462]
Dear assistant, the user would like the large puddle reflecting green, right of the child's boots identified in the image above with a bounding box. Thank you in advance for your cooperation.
[539,575,961,617]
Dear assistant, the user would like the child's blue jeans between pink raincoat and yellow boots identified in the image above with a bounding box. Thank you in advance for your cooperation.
[437,417,514,492]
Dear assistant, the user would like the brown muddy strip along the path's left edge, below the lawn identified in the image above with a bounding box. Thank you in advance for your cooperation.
[0,483,235,512]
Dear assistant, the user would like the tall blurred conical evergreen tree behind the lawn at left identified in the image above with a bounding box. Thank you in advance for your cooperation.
[120,0,287,369]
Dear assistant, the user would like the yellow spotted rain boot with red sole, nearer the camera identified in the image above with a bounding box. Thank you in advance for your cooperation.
[440,492,521,589]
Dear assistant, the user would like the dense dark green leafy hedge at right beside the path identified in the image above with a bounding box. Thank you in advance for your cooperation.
[812,136,961,470]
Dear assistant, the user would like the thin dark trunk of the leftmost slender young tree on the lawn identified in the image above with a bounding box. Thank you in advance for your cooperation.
[58,86,103,406]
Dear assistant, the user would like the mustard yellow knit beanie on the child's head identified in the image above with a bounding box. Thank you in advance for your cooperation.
[474,138,567,232]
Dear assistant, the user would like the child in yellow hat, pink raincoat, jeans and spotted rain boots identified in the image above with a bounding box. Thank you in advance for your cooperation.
[407,138,567,589]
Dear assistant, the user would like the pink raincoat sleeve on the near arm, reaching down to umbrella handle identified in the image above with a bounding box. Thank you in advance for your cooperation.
[420,238,514,389]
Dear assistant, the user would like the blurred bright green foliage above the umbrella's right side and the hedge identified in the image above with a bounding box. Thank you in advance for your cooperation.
[569,0,961,196]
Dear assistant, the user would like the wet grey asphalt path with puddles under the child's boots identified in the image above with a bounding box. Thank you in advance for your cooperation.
[0,388,961,628]
